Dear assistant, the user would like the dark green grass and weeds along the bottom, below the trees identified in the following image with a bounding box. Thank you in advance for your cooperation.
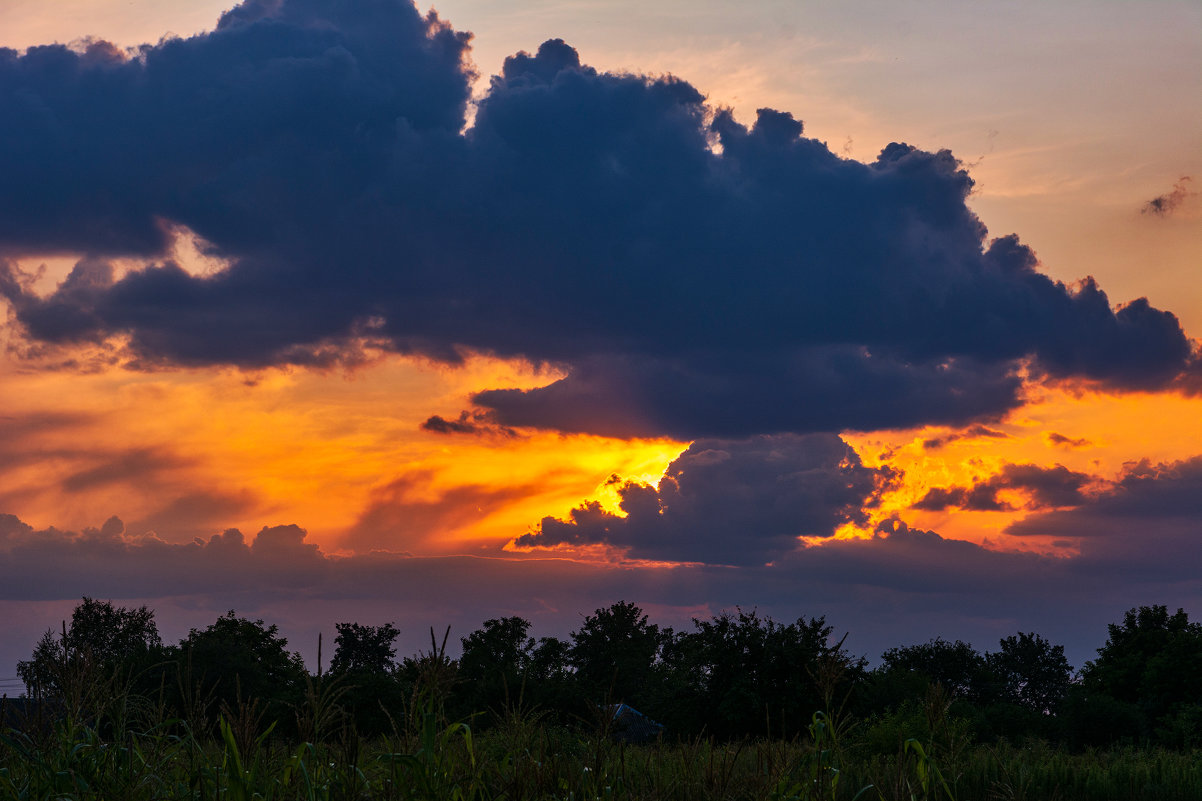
[0,684,1202,801]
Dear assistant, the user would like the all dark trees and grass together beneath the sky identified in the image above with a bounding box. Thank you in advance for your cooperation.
[0,598,1202,801]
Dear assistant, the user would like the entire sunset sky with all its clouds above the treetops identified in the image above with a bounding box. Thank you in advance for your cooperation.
[0,0,1202,688]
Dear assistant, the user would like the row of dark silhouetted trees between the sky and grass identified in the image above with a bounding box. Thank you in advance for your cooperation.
[17,598,1202,748]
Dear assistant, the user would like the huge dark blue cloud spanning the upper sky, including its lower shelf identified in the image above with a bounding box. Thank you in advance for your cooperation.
[0,0,1191,439]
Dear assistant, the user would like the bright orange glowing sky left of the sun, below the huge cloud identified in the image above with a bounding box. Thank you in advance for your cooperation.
[4,343,684,553]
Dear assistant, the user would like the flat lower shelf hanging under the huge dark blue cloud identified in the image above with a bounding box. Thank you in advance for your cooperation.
[472,345,1022,440]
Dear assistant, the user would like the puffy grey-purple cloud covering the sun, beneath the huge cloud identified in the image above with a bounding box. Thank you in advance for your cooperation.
[517,434,895,565]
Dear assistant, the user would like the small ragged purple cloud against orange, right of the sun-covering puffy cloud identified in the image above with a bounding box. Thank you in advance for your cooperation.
[911,464,1097,511]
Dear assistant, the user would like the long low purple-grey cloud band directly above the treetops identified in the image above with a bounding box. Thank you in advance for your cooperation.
[0,505,1202,664]
